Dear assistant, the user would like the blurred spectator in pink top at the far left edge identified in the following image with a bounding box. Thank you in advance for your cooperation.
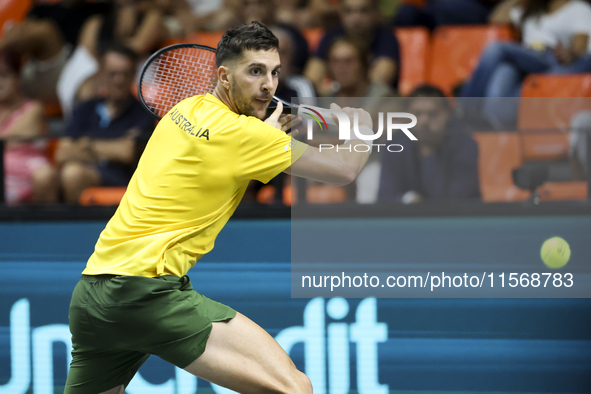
[0,50,57,205]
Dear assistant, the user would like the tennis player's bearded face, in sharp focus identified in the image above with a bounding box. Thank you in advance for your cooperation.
[228,49,281,119]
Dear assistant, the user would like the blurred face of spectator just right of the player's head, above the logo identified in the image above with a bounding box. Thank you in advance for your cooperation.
[328,42,366,89]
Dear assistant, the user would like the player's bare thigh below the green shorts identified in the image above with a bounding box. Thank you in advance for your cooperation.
[185,313,312,394]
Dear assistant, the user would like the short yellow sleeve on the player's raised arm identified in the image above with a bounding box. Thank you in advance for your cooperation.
[236,118,308,183]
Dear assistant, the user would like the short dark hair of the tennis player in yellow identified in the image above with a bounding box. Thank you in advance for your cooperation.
[215,21,279,67]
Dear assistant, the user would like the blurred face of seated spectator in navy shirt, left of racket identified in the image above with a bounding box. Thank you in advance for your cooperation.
[103,52,135,101]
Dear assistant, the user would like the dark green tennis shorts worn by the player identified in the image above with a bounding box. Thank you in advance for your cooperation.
[64,275,236,394]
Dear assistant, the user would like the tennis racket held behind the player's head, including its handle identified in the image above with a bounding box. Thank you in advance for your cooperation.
[138,44,336,125]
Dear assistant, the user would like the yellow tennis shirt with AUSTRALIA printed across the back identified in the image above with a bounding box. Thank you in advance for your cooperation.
[83,94,308,277]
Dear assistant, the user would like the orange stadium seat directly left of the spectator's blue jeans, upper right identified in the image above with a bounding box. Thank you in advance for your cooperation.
[429,25,514,95]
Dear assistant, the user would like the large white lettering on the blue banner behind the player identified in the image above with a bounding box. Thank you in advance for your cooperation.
[0,298,388,394]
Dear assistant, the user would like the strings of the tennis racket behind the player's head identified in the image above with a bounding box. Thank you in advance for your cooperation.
[140,47,217,118]
